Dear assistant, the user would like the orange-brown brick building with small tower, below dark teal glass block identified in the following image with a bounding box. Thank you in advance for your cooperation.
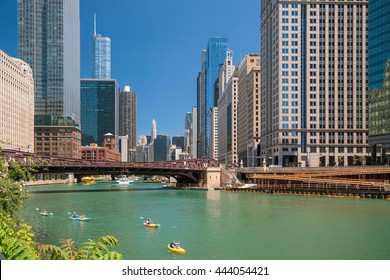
[81,133,121,161]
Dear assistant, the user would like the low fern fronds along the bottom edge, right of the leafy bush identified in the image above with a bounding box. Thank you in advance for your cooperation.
[38,236,123,260]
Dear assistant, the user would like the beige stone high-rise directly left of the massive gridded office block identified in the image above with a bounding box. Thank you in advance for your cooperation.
[237,54,261,166]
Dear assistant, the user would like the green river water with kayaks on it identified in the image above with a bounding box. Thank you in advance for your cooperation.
[20,182,390,260]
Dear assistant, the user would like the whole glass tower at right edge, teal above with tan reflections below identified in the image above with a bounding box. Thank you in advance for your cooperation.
[368,0,390,159]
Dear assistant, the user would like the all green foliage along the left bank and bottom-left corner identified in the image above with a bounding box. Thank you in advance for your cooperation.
[0,149,123,260]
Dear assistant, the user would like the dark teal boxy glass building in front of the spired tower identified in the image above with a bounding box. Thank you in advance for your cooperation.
[80,79,119,146]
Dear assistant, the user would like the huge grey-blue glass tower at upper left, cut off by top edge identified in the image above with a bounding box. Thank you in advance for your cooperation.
[18,0,80,123]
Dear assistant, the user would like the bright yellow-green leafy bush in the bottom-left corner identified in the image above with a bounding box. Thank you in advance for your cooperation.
[0,213,38,260]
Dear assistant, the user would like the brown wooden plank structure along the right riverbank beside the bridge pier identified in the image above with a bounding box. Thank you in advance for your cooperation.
[227,166,390,200]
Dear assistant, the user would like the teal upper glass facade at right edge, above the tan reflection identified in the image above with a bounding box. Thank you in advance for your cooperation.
[368,0,390,90]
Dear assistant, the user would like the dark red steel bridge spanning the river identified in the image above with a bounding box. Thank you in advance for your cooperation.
[0,150,219,184]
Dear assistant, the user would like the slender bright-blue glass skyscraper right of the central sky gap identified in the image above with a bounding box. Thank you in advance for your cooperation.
[197,38,228,157]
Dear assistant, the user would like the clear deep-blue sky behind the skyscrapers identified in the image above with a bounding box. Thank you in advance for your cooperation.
[0,0,260,140]
